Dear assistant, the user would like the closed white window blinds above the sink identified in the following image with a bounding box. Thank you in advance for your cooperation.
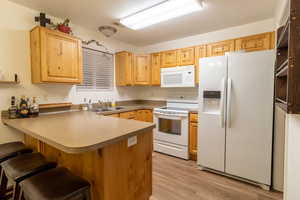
[77,48,114,91]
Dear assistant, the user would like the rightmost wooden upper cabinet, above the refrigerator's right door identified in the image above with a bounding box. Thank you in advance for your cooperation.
[235,33,274,52]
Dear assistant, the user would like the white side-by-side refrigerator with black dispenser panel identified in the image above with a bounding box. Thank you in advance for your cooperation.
[198,50,275,189]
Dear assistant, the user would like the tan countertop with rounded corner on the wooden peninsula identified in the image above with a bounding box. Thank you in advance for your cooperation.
[2,111,155,153]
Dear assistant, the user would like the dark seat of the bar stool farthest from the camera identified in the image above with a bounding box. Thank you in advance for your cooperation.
[0,142,32,163]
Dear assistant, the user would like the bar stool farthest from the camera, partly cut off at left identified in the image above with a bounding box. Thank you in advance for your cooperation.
[0,142,32,199]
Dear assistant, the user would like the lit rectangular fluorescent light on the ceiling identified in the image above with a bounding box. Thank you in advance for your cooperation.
[120,0,202,30]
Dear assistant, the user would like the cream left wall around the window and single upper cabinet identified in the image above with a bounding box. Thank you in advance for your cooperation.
[0,0,137,143]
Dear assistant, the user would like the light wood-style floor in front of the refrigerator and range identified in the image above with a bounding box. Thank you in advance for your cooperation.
[151,153,283,200]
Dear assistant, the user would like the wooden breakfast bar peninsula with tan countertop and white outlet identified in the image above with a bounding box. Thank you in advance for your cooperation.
[2,111,155,200]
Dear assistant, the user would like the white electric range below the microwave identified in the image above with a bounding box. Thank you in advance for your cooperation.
[154,100,198,159]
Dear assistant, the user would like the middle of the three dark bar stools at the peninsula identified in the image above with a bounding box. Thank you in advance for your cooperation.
[1,153,56,200]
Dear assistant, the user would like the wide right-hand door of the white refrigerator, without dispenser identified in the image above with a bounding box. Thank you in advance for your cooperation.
[225,51,275,185]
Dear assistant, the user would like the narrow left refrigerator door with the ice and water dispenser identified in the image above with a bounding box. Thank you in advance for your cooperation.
[197,56,227,172]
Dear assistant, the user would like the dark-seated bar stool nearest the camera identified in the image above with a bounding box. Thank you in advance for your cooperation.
[20,167,91,200]
